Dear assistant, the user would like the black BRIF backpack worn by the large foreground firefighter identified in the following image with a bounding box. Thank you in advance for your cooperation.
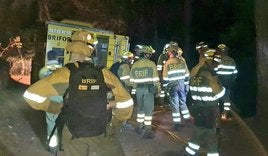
[62,63,112,137]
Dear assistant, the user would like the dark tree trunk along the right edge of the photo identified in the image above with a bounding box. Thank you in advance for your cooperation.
[255,0,268,129]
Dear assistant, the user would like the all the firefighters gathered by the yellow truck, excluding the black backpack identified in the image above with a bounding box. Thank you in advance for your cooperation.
[23,30,237,156]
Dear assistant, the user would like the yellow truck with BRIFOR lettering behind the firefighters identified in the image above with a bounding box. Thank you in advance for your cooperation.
[45,19,129,68]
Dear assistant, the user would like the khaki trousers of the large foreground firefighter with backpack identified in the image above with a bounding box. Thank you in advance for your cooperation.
[62,126,125,156]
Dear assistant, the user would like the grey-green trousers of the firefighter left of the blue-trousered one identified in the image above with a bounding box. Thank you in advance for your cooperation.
[136,85,155,129]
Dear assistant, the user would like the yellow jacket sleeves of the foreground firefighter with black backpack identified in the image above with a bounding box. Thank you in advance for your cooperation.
[23,63,133,121]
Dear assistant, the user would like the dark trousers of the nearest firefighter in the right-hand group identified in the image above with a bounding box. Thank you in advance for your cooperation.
[185,101,219,153]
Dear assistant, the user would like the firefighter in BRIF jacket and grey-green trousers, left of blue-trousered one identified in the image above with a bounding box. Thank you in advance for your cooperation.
[130,45,160,139]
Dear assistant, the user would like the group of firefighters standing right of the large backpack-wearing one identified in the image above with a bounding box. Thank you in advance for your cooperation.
[117,41,237,156]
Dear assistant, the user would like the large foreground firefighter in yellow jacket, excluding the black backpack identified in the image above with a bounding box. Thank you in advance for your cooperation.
[23,30,133,156]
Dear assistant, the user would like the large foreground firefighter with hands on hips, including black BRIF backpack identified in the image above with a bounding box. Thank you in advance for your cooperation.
[23,30,133,156]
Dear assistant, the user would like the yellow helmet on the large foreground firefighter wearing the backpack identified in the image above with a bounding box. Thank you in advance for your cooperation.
[65,30,98,56]
